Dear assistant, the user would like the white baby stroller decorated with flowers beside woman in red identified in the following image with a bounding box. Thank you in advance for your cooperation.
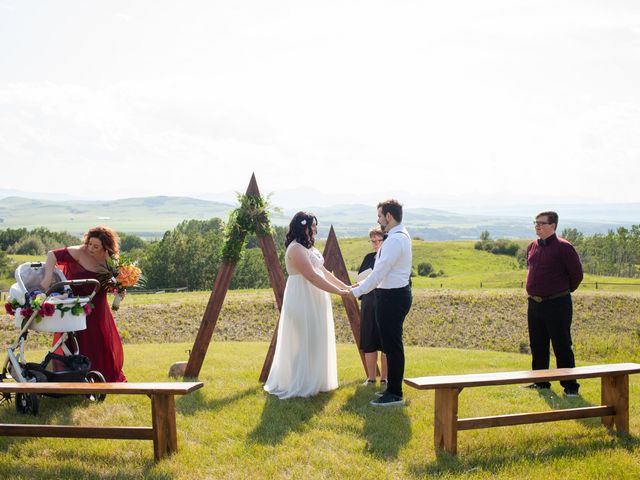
[0,262,105,415]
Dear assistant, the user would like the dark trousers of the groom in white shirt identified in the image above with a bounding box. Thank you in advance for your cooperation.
[375,285,412,396]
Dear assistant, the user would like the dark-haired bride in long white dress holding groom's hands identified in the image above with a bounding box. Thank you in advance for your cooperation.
[264,212,349,399]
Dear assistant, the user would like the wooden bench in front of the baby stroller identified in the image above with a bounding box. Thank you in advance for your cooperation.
[0,382,203,461]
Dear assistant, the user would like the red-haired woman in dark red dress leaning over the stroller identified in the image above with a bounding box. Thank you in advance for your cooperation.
[42,227,127,382]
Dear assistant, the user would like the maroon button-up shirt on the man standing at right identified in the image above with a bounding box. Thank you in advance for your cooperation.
[527,234,582,297]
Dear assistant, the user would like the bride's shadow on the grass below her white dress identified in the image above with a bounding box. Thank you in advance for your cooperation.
[247,392,333,445]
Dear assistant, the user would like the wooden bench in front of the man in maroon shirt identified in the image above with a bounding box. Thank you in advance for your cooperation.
[404,363,640,455]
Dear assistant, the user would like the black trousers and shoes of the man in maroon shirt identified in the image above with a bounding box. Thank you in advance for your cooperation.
[527,295,580,391]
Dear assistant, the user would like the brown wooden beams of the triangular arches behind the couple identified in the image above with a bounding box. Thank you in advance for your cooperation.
[184,174,366,382]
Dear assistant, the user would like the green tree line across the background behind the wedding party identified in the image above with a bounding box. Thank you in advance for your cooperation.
[0,222,640,290]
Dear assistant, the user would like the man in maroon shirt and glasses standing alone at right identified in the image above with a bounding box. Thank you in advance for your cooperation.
[527,212,582,397]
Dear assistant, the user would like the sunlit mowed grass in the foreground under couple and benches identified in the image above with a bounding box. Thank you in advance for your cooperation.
[0,342,640,480]
